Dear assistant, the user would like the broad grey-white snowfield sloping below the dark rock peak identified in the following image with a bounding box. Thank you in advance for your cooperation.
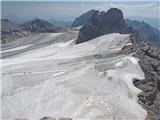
[1,33,147,120]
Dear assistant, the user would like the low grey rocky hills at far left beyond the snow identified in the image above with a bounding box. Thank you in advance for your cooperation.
[1,18,67,44]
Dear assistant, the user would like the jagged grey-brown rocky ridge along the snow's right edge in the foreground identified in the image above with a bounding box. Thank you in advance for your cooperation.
[122,35,160,120]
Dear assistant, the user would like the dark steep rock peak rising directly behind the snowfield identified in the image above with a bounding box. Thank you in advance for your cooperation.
[76,8,127,44]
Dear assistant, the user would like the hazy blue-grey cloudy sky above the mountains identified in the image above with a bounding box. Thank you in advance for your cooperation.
[1,0,160,21]
